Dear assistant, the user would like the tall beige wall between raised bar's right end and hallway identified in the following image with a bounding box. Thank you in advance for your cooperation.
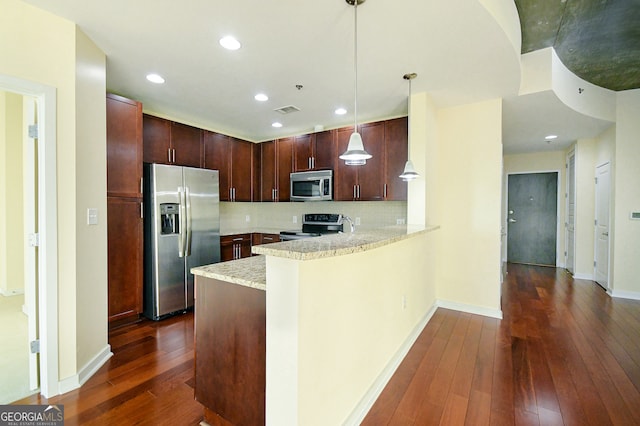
[436,99,502,311]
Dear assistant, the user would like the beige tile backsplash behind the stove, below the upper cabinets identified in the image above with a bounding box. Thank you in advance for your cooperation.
[220,201,407,235]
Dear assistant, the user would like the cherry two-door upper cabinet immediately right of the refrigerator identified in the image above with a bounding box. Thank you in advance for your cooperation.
[203,130,254,201]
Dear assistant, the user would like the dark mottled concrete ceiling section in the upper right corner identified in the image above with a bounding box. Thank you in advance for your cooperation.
[515,0,640,91]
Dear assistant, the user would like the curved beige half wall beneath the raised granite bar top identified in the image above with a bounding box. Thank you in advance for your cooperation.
[267,230,439,425]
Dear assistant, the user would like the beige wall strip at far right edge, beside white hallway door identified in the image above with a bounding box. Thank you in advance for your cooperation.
[611,90,640,297]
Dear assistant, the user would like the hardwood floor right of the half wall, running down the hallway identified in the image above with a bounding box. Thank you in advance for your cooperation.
[362,264,640,426]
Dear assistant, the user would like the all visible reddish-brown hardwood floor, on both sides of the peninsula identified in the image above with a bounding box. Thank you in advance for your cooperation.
[13,265,640,426]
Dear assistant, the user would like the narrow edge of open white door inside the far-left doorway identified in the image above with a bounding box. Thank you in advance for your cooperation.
[22,96,40,390]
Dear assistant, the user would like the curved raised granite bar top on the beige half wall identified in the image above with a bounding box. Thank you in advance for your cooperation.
[252,225,439,260]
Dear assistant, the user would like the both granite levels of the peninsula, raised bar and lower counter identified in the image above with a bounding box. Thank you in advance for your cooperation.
[191,226,439,290]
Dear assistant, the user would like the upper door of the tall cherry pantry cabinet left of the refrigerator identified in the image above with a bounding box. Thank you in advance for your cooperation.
[107,93,142,198]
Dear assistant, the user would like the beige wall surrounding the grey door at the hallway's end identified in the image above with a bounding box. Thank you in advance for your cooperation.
[501,151,567,267]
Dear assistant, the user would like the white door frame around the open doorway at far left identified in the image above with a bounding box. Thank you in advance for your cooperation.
[0,74,59,398]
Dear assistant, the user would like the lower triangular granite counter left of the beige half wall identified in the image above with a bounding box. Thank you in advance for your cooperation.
[191,256,267,290]
